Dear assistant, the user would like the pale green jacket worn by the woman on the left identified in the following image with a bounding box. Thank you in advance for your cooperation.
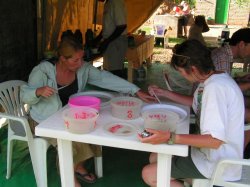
[21,61,139,123]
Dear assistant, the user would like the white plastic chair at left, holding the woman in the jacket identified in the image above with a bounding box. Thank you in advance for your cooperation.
[0,80,49,187]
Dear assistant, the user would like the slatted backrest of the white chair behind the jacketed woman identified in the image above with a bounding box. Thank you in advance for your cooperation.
[0,80,27,136]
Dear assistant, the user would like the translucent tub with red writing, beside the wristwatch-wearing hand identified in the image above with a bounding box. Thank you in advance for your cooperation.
[142,110,180,132]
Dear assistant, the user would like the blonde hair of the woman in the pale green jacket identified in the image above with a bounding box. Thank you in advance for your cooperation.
[57,37,83,58]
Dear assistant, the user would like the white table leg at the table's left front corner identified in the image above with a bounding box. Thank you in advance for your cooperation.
[57,139,75,187]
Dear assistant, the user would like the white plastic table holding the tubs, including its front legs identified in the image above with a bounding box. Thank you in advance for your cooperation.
[35,102,189,187]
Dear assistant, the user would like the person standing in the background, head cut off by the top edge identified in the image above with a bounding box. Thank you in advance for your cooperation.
[95,0,128,78]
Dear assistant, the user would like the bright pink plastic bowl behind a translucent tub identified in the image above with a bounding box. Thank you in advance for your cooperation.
[68,95,101,111]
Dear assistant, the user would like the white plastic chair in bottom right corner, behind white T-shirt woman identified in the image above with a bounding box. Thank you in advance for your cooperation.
[192,159,250,187]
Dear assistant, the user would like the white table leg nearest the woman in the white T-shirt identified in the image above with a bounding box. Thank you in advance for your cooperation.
[157,154,172,187]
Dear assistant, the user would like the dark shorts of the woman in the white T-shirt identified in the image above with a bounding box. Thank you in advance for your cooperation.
[171,152,206,179]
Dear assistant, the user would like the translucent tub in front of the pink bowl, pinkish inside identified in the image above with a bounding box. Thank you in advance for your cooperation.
[62,107,99,134]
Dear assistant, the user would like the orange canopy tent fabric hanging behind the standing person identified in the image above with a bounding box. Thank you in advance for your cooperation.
[38,0,163,55]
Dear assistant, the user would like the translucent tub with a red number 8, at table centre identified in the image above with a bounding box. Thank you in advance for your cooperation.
[110,97,143,120]
